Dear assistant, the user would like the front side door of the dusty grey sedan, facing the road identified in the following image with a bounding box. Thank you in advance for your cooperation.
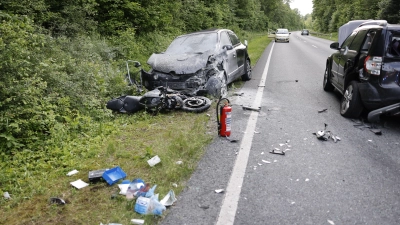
[220,31,238,83]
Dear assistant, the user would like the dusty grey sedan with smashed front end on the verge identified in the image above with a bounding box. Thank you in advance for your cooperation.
[141,29,251,97]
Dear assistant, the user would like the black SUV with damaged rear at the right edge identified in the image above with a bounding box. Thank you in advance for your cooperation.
[323,20,400,121]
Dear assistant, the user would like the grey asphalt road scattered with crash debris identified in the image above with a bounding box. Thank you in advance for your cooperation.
[161,32,400,225]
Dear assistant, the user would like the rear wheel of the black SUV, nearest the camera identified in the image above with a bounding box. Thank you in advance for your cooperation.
[340,81,364,118]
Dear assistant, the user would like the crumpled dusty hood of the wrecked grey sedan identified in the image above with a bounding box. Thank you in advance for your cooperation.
[147,51,211,74]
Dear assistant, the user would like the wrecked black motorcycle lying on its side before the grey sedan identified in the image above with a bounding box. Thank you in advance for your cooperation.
[106,61,211,115]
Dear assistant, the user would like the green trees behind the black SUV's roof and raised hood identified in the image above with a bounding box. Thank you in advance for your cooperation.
[312,0,400,32]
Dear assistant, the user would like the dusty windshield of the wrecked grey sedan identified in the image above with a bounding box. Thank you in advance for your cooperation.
[165,33,217,54]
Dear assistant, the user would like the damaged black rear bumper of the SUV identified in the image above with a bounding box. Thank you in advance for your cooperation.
[358,82,400,110]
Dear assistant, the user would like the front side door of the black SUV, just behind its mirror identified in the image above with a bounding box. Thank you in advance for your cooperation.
[331,32,357,89]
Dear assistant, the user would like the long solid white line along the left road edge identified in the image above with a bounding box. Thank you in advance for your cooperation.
[216,42,275,225]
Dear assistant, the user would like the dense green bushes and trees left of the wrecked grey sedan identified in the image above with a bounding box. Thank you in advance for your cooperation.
[0,0,301,160]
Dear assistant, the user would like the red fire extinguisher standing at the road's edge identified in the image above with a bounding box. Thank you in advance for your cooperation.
[216,98,232,137]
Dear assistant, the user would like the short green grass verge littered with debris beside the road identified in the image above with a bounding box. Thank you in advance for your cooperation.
[0,33,271,224]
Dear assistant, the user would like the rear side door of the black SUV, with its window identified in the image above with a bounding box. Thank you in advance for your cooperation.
[337,30,367,90]
